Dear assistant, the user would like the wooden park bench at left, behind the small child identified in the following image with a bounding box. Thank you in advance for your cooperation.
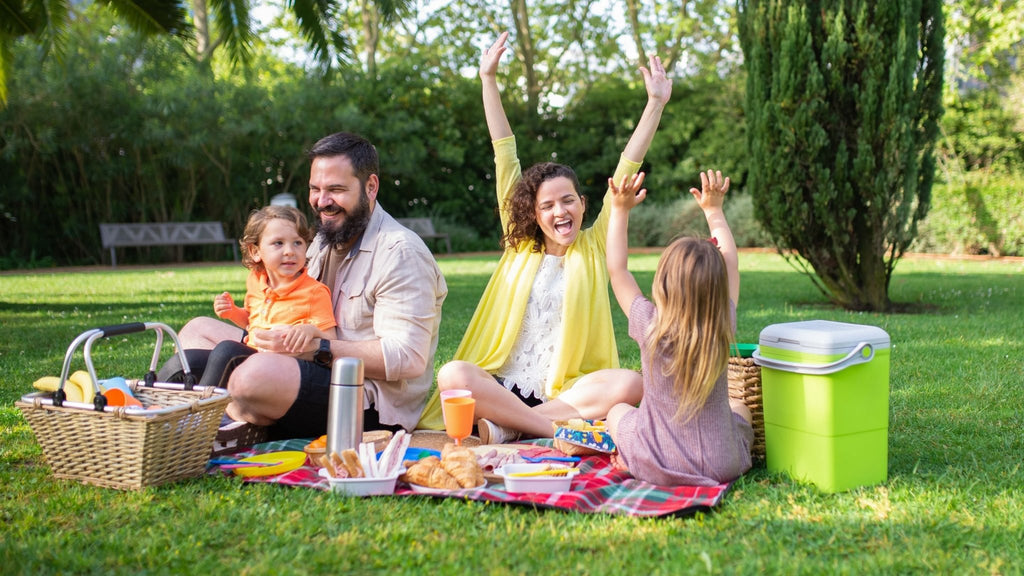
[99,222,239,268]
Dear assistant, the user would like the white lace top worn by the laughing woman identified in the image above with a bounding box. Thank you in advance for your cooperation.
[497,254,565,402]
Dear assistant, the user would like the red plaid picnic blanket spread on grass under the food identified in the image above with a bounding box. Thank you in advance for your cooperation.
[209,439,729,517]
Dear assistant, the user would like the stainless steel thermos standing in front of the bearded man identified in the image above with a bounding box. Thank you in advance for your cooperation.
[327,358,362,454]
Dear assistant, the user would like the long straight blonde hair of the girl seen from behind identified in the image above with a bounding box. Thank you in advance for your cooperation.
[646,238,733,423]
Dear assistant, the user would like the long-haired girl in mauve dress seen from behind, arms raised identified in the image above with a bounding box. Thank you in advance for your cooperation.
[606,170,754,486]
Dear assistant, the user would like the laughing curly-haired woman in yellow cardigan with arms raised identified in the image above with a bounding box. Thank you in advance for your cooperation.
[420,32,672,444]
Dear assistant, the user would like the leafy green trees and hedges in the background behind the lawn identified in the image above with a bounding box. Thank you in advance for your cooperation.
[0,0,1024,269]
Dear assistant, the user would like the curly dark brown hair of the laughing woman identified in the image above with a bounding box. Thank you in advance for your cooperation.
[501,162,583,252]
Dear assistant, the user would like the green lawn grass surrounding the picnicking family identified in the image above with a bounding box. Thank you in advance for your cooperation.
[0,253,1024,574]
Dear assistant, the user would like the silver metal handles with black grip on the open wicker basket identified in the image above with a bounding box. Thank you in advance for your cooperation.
[53,322,196,412]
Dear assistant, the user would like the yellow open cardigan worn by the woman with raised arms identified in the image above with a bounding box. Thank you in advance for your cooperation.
[418,136,640,429]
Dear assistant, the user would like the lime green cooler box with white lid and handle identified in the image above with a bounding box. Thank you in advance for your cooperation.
[754,320,889,492]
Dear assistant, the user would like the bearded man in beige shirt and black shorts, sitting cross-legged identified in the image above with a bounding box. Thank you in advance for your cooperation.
[160,132,447,444]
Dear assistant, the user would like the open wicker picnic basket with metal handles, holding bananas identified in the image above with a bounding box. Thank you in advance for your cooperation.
[15,322,230,490]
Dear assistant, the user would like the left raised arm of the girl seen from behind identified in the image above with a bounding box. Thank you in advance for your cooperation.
[604,172,647,316]
